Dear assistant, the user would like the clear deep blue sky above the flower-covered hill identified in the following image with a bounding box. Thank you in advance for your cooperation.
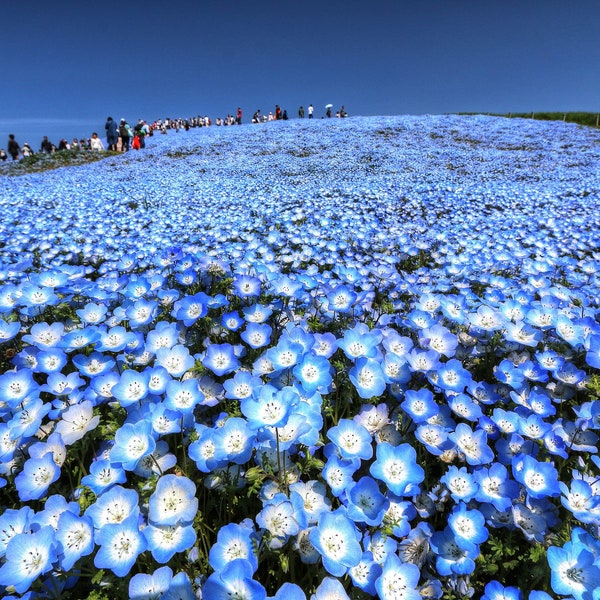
[0,0,600,149]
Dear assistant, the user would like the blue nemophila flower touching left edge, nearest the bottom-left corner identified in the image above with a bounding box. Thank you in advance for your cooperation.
[0,525,57,594]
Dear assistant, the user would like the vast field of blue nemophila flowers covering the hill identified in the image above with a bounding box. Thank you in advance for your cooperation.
[0,116,600,600]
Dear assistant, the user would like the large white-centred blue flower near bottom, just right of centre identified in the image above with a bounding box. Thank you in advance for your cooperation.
[309,512,362,577]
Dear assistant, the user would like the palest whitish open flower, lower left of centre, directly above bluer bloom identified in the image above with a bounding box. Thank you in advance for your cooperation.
[148,475,198,525]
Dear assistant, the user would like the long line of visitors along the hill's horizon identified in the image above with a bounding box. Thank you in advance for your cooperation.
[0,104,348,161]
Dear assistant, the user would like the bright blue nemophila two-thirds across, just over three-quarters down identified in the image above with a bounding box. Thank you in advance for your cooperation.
[369,442,425,496]
